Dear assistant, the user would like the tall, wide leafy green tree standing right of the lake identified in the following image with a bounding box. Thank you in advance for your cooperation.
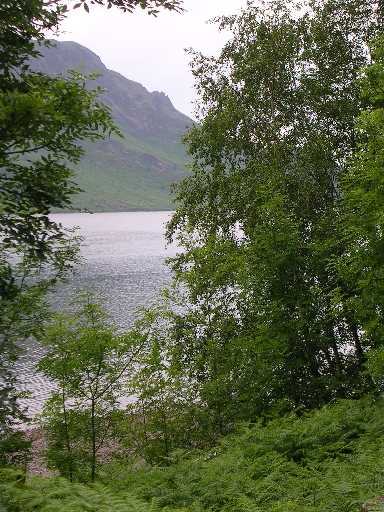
[142,0,383,440]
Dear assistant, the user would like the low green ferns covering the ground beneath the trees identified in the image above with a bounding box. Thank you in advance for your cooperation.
[0,398,384,512]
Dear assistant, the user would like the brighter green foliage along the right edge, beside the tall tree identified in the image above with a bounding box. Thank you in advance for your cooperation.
[335,35,384,377]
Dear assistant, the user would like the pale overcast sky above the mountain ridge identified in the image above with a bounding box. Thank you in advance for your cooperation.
[59,0,246,115]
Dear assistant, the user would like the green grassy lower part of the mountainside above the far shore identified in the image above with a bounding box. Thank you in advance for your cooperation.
[61,132,187,212]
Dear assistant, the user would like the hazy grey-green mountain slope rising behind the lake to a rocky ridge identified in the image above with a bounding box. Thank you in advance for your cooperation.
[31,41,192,211]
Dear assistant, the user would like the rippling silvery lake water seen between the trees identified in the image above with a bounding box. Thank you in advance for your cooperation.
[18,212,176,414]
